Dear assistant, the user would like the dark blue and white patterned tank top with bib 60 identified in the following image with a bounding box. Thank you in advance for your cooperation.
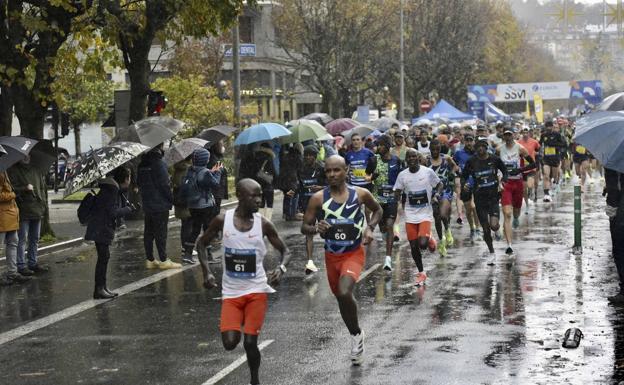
[322,186,365,254]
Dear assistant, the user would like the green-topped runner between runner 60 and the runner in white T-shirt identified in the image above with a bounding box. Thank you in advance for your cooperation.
[373,135,403,271]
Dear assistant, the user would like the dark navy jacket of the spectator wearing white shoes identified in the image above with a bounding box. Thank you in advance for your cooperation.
[137,150,173,214]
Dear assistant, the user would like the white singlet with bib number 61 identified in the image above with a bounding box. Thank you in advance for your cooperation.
[222,209,275,298]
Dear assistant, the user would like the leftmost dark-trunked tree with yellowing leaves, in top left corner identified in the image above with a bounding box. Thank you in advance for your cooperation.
[0,0,92,138]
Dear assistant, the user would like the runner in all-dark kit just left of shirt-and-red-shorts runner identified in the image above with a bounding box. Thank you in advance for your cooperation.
[462,138,507,265]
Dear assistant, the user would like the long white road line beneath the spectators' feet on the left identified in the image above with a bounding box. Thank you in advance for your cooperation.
[0,265,198,346]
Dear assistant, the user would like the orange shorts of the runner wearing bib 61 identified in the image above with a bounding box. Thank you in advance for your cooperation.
[221,293,269,336]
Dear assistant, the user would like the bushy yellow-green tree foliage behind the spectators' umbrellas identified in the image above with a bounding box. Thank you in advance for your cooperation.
[152,75,234,138]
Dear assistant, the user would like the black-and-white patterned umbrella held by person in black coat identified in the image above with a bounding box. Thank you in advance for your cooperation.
[63,142,150,197]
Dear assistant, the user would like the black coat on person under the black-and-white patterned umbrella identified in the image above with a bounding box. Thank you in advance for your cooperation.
[85,178,132,245]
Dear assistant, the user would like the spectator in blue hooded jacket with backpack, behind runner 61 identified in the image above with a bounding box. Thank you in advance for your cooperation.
[184,148,222,264]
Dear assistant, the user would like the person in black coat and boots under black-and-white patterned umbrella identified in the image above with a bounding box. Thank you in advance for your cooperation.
[85,167,133,299]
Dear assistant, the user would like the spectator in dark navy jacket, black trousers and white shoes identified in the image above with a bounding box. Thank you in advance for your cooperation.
[137,143,182,270]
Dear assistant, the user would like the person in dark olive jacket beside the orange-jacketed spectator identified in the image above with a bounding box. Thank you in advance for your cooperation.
[8,156,48,276]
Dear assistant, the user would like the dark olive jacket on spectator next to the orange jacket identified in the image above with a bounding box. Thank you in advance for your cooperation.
[8,162,48,220]
